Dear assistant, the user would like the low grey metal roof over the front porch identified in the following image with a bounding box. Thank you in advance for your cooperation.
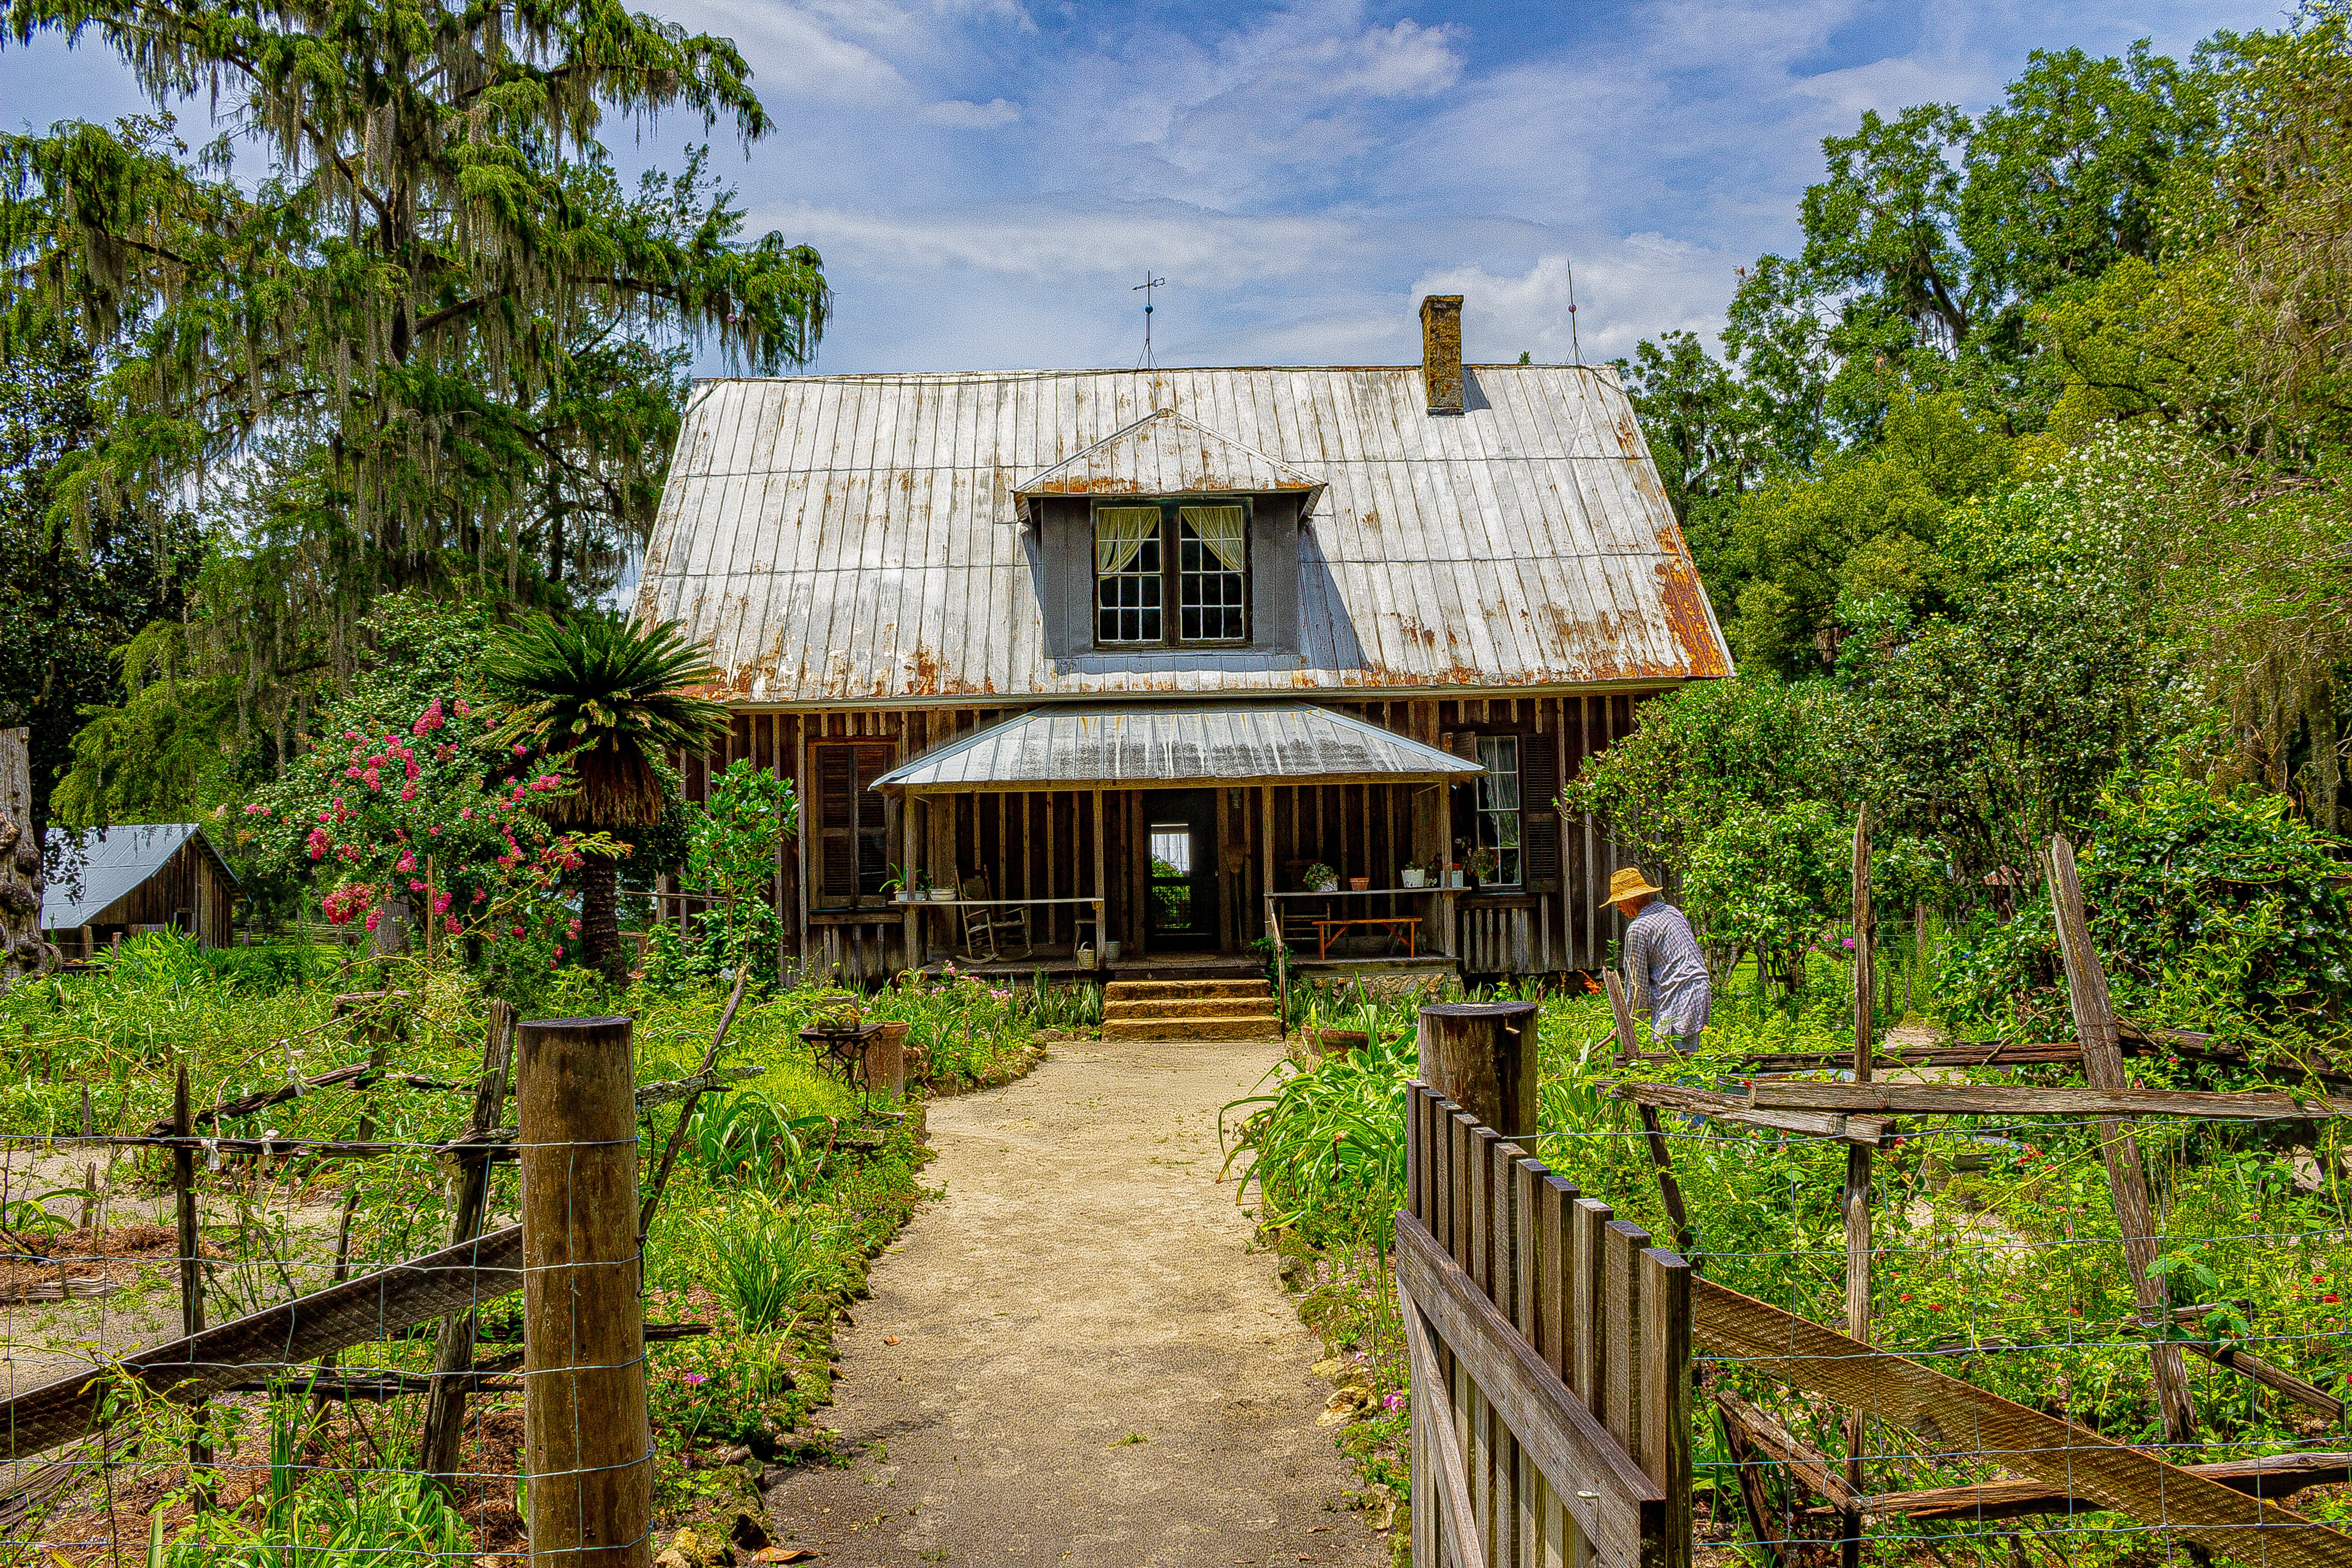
[872,703,1484,790]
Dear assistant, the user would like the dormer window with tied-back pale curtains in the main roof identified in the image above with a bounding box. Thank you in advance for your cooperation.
[1094,498,1249,649]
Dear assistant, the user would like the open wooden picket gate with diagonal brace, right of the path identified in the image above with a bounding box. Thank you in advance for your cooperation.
[1397,1081,1691,1568]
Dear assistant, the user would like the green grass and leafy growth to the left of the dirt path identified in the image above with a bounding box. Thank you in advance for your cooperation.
[0,938,1049,1568]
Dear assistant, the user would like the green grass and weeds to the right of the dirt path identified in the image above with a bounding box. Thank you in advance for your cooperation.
[1228,964,2352,1563]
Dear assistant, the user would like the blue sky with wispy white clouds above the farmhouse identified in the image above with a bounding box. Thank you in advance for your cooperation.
[0,0,2286,372]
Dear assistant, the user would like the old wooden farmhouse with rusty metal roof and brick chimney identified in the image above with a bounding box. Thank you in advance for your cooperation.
[637,296,1731,980]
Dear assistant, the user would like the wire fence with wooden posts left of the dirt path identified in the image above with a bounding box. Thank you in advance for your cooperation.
[0,983,903,1568]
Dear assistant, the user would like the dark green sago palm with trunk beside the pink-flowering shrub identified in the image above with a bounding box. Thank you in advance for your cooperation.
[489,613,727,983]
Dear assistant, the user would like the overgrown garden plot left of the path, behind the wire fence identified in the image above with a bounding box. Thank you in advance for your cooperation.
[0,938,1075,1566]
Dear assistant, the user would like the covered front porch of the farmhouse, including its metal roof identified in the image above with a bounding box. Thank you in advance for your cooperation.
[868,703,1480,978]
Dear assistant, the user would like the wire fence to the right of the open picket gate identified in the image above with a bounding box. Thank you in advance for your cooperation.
[1522,1100,2352,1566]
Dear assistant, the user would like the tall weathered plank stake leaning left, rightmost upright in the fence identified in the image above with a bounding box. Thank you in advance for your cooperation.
[2051,832,2197,1446]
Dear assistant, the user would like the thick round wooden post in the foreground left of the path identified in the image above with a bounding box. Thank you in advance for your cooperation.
[515,1018,654,1568]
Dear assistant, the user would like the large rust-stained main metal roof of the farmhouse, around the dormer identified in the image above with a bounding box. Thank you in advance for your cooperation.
[637,364,1731,705]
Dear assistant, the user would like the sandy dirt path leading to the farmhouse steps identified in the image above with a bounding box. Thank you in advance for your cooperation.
[767,1041,1388,1568]
